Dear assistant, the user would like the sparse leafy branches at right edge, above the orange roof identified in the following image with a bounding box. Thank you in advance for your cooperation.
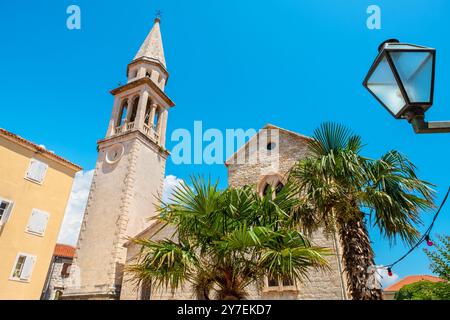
[424,236,450,281]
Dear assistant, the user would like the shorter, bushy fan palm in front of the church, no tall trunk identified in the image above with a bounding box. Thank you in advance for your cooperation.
[127,178,328,300]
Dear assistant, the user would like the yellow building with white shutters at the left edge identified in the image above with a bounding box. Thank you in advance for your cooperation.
[0,128,81,300]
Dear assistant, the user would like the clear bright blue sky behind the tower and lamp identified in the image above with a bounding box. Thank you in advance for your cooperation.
[0,0,450,284]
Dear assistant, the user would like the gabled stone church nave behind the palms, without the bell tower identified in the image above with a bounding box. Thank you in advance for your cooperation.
[121,124,347,300]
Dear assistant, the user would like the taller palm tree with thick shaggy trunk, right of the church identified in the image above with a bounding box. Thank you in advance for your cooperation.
[289,123,434,299]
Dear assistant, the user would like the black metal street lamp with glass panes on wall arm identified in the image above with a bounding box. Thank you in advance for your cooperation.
[363,39,450,133]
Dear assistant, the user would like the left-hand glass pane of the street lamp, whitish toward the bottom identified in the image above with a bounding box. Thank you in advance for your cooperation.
[367,57,406,115]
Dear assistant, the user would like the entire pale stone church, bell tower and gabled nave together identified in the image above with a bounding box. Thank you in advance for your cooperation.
[63,18,347,300]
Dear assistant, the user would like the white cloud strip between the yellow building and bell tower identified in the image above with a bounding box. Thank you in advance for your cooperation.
[58,170,94,246]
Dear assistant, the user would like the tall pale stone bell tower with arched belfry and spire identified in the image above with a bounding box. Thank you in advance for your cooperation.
[64,18,174,299]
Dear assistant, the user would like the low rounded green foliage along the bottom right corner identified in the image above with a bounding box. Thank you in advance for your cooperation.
[395,281,450,300]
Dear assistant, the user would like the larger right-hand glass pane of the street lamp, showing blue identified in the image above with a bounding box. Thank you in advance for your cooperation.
[389,51,433,103]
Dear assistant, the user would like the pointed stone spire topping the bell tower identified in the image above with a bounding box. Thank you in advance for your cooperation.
[134,10,166,68]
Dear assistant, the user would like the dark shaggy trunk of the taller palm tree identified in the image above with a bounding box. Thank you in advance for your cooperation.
[339,217,382,300]
